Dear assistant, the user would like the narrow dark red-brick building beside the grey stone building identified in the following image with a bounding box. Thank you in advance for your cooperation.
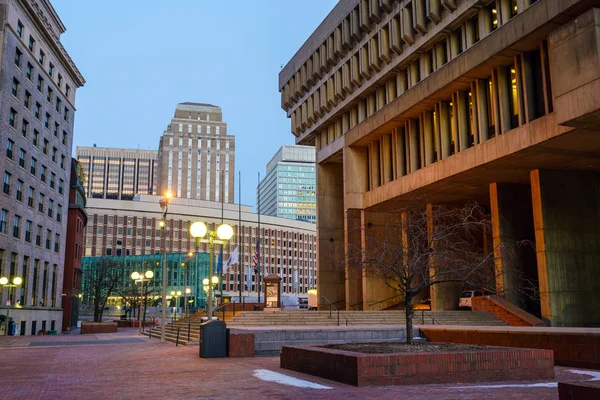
[62,158,87,330]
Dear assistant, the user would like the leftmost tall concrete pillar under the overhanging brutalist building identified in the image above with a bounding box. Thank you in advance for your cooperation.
[317,163,346,307]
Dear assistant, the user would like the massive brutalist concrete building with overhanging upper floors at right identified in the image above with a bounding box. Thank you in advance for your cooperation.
[279,0,600,326]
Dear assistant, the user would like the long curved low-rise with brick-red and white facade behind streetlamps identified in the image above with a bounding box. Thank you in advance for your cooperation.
[85,196,316,296]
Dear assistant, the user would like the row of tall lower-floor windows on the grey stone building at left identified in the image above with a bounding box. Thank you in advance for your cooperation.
[0,248,58,307]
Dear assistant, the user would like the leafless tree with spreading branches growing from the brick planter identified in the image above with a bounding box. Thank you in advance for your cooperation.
[346,203,500,344]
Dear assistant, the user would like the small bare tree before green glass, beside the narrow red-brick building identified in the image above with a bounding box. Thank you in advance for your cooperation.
[83,257,123,322]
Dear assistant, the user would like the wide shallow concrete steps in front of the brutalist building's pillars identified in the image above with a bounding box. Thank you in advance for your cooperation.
[227,310,506,328]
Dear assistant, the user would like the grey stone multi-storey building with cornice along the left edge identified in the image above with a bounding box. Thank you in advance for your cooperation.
[0,0,85,335]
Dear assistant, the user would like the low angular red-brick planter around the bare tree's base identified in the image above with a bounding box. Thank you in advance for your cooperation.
[281,346,554,386]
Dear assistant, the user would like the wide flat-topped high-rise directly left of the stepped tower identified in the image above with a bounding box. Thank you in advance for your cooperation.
[76,146,158,200]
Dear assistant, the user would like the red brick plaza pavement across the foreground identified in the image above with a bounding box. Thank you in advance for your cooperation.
[0,331,589,400]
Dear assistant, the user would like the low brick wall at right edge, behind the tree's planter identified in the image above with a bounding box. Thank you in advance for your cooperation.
[421,327,600,369]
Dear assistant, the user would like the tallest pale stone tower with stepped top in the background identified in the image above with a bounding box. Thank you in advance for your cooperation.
[158,103,235,203]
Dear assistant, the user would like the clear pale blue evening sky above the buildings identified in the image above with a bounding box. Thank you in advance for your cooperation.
[51,0,337,209]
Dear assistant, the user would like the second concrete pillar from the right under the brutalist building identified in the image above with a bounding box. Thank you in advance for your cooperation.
[490,183,540,317]
